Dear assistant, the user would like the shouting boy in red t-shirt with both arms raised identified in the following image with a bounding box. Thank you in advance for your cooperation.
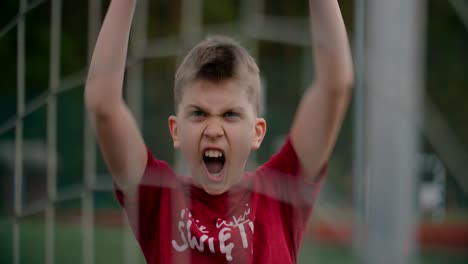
[85,0,353,263]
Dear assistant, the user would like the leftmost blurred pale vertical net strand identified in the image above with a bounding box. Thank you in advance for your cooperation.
[13,0,27,264]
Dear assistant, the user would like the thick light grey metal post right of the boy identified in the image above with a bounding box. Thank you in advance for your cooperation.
[364,0,425,264]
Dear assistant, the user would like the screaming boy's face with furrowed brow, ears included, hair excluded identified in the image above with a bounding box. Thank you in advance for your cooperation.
[169,80,266,194]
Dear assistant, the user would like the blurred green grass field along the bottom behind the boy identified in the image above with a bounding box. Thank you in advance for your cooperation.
[0,220,468,264]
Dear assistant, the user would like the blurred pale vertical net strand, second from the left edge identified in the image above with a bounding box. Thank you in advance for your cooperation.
[45,0,62,264]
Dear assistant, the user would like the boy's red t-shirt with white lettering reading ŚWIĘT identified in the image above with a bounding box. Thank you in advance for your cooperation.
[116,139,326,264]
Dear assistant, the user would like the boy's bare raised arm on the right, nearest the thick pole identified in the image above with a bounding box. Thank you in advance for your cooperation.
[291,0,353,181]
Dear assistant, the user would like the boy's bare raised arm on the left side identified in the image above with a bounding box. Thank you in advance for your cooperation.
[85,0,147,190]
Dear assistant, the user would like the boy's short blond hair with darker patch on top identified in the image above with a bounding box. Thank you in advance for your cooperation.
[174,36,260,114]
